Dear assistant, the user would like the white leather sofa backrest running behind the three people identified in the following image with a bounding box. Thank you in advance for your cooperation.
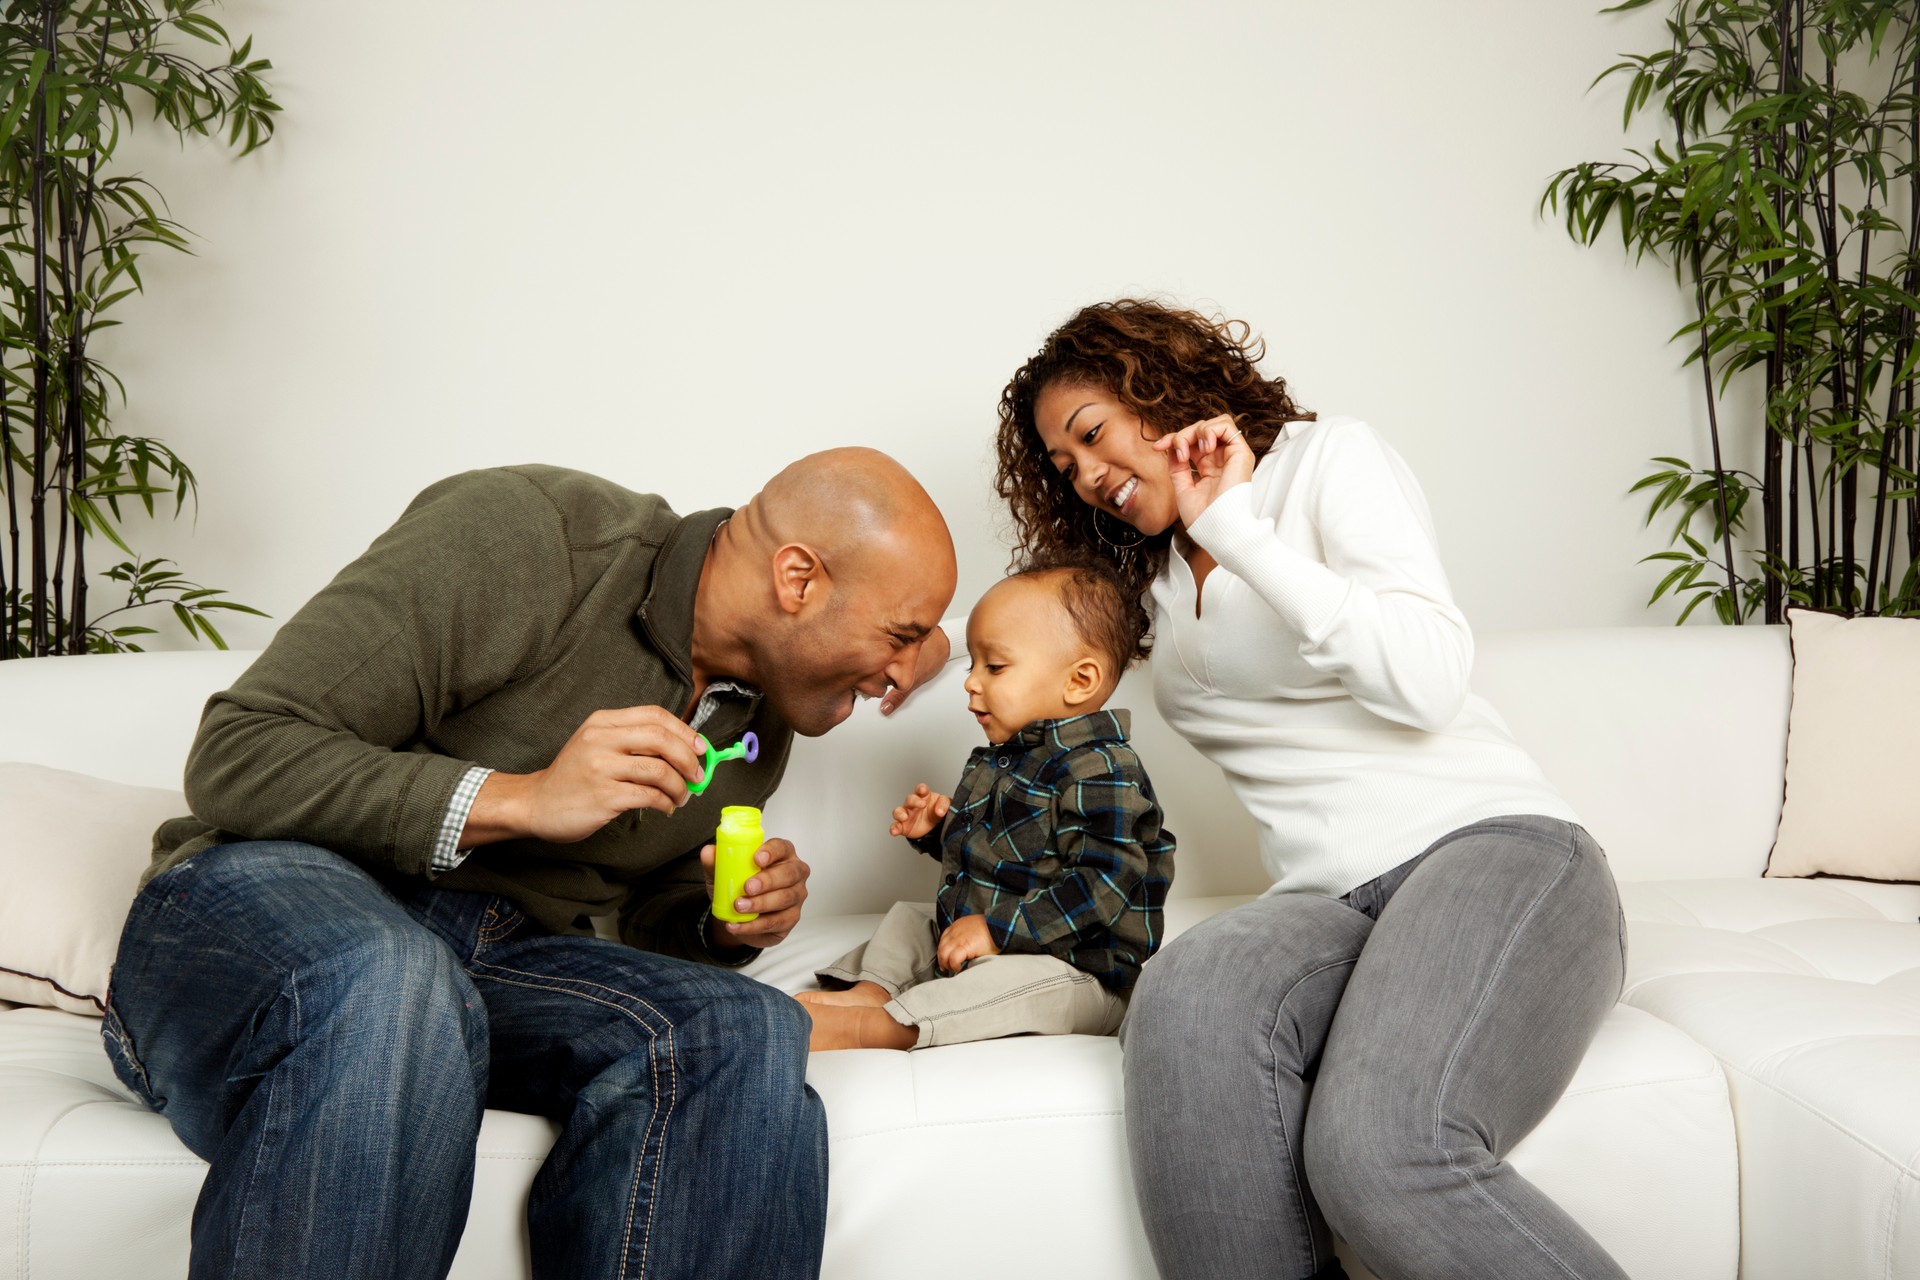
[0,628,1789,913]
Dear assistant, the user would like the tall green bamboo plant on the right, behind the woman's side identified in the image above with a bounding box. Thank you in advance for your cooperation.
[1540,0,1920,624]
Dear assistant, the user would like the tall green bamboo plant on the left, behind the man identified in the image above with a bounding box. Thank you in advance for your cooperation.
[0,0,280,658]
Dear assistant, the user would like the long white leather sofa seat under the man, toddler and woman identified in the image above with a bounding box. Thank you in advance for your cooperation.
[0,898,1740,1280]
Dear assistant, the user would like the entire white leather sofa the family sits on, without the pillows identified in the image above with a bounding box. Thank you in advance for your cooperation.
[0,628,1920,1280]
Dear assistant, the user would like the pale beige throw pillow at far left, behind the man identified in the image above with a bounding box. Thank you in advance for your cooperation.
[0,764,186,1017]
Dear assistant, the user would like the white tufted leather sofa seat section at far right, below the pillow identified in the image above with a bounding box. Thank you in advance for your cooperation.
[1620,879,1920,1280]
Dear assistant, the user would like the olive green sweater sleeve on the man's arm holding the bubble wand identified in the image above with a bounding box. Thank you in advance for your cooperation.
[186,472,570,875]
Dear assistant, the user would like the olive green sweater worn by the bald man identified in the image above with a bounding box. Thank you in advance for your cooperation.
[148,466,793,960]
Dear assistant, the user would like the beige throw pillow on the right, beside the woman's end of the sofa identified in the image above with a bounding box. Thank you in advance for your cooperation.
[1766,608,1920,881]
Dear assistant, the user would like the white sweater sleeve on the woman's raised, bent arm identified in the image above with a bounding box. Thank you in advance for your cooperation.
[1188,422,1473,729]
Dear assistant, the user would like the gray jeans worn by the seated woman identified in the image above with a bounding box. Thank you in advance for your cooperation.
[1121,818,1626,1280]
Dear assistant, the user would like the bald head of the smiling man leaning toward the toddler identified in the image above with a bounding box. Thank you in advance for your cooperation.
[714,449,956,737]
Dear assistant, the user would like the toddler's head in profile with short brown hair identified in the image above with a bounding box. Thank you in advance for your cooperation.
[966,564,1139,745]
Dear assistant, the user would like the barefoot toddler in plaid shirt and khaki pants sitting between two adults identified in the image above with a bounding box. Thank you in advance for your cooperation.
[799,566,1173,1052]
